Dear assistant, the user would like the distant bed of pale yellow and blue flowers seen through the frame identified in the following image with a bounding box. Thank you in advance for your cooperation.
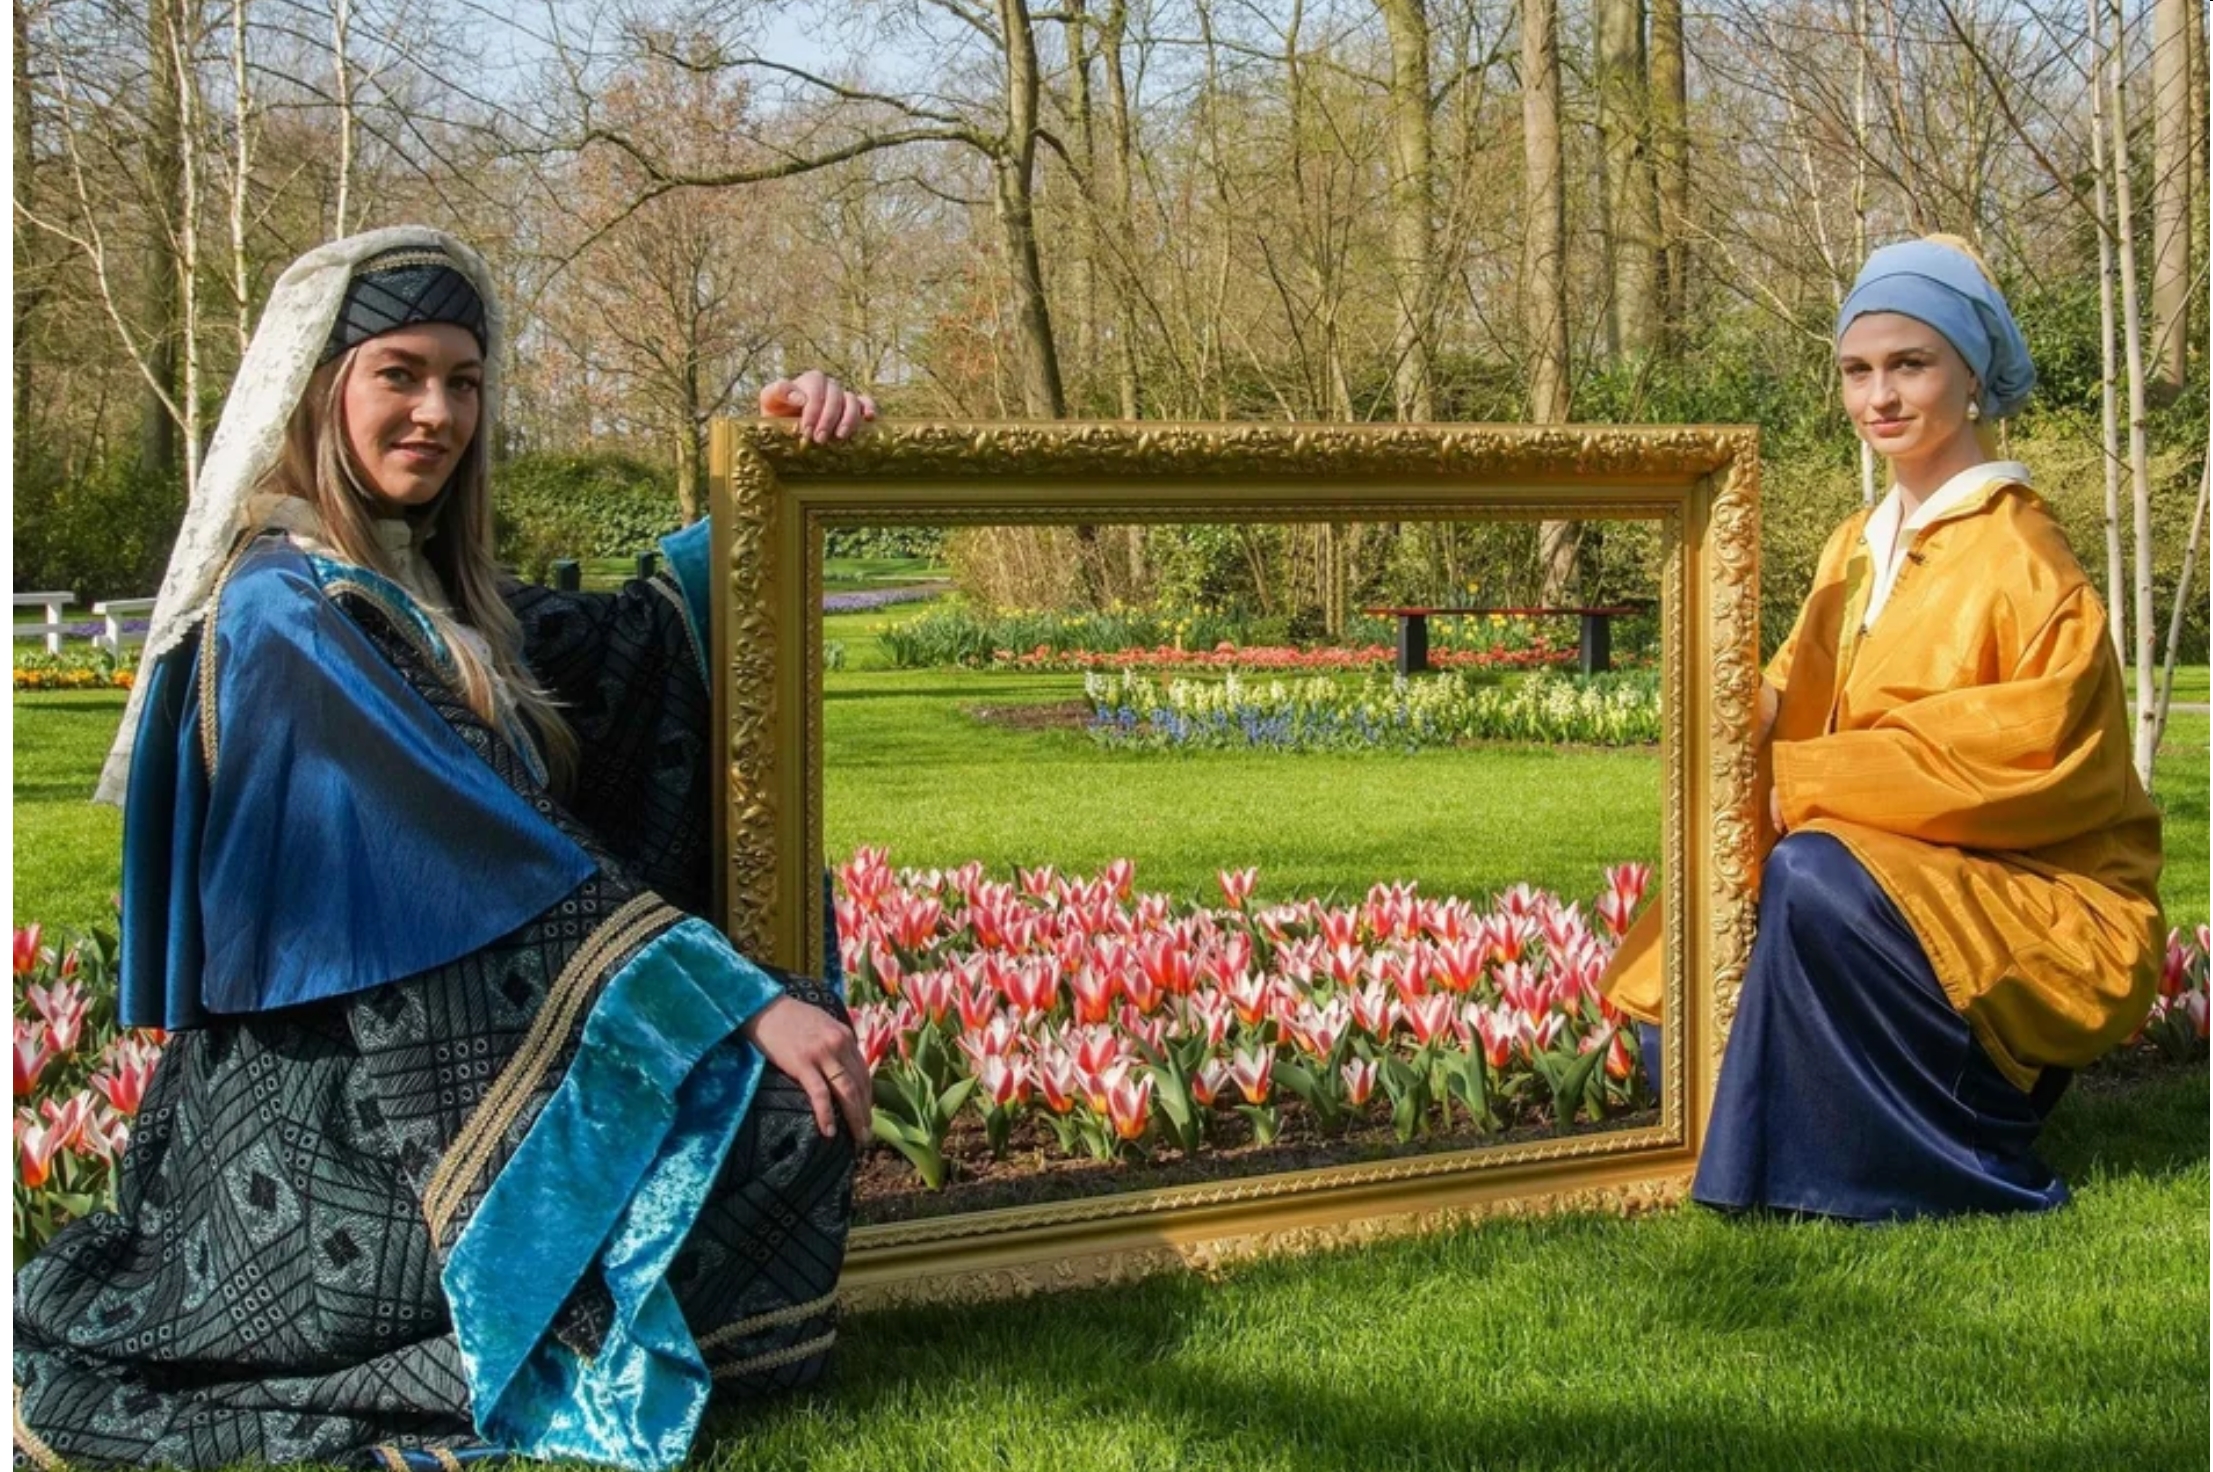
[1084,671,1660,750]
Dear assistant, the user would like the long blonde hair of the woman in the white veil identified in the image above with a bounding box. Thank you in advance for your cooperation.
[261,348,580,790]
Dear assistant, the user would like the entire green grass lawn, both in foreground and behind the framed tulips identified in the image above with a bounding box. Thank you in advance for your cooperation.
[15,637,2213,1472]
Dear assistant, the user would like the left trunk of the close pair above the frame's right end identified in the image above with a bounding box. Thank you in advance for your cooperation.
[1598,0,1660,359]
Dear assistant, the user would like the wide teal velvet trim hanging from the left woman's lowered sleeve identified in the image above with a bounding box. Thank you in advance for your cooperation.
[440,919,781,1472]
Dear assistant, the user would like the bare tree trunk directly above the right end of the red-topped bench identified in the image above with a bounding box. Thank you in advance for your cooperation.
[1523,0,1578,600]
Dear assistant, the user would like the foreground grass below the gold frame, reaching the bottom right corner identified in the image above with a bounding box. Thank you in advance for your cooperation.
[706,1071,2206,1472]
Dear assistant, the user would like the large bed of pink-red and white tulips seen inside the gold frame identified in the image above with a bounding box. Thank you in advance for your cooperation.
[837,848,1649,1191]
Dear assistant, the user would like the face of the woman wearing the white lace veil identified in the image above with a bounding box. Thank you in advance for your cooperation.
[339,323,485,509]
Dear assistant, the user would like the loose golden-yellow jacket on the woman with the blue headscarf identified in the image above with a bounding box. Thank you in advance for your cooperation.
[1602,480,2164,1089]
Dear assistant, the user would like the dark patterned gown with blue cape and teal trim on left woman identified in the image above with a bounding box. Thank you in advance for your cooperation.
[15,536,852,1472]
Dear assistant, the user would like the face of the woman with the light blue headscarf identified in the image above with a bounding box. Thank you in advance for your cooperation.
[1837,312,1981,476]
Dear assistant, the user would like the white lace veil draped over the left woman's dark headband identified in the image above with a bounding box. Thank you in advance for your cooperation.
[93,226,505,806]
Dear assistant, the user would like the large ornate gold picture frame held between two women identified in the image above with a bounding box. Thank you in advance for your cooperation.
[708,421,1759,1304]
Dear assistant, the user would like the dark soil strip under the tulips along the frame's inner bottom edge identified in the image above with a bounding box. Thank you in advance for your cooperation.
[854,1096,1660,1226]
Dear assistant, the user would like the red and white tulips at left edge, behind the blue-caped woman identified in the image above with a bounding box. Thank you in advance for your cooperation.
[13,925,166,1262]
